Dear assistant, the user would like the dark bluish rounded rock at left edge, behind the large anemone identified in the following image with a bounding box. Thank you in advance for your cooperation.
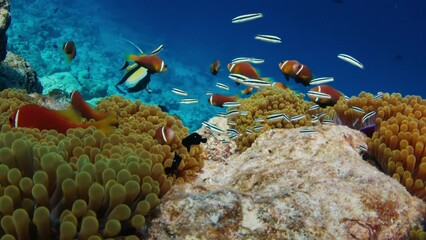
[0,52,43,93]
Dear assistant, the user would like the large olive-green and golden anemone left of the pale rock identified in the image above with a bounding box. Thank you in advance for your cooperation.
[0,89,205,239]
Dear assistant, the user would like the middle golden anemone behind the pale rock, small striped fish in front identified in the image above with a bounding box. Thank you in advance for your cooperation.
[229,87,323,151]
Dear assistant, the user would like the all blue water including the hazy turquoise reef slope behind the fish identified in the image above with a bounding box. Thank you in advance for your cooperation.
[8,0,426,131]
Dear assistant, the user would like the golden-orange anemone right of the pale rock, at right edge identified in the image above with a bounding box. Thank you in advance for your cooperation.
[334,92,426,201]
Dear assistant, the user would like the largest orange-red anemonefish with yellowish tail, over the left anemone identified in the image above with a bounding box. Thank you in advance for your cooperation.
[9,104,117,135]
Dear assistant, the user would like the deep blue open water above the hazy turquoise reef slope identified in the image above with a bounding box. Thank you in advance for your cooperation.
[93,0,426,98]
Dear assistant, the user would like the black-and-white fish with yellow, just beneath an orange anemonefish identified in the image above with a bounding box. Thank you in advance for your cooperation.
[115,63,152,95]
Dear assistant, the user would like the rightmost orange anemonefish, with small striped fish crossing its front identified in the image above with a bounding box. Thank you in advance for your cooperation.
[308,85,345,108]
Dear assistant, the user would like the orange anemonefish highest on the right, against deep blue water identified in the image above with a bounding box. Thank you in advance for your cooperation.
[278,60,314,86]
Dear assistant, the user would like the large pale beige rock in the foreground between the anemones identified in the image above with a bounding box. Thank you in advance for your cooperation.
[149,125,426,239]
